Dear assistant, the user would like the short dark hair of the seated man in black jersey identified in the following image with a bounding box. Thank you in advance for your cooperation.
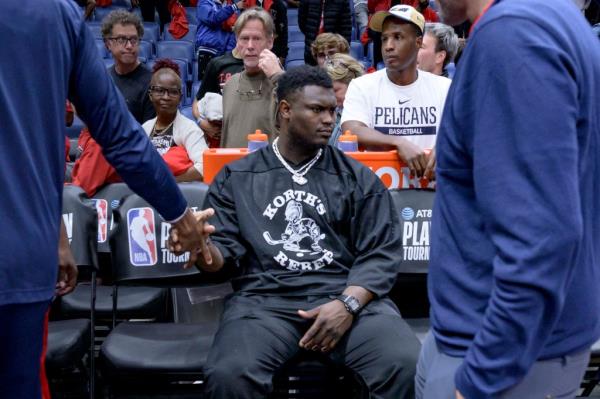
[277,65,333,101]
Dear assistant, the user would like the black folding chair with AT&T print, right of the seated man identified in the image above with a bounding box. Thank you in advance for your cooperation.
[390,189,435,342]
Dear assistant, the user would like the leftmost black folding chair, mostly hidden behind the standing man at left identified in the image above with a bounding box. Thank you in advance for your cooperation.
[46,185,98,399]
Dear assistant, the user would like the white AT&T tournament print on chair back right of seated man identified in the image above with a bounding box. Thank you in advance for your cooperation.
[400,207,431,261]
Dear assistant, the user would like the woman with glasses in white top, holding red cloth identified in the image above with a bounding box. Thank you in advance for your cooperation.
[142,59,208,182]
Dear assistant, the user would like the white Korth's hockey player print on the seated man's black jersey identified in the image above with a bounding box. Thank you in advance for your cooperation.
[262,190,333,270]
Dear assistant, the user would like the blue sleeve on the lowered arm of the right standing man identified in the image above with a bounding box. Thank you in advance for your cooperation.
[455,18,582,399]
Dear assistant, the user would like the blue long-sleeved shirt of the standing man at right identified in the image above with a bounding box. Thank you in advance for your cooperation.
[429,0,600,398]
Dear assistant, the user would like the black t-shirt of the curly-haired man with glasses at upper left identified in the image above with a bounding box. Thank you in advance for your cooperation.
[108,63,156,124]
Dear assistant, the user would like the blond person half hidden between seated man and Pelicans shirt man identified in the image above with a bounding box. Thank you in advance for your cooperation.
[324,53,364,146]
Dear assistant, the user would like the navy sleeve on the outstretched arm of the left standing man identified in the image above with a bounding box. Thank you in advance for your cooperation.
[69,18,186,220]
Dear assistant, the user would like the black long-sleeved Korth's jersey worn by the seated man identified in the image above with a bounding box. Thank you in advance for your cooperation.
[205,146,402,296]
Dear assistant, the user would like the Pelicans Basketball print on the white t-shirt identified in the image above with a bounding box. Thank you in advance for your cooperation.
[374,104,438,136]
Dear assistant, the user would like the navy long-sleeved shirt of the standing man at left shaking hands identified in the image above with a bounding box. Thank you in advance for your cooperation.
[0,0,186,305]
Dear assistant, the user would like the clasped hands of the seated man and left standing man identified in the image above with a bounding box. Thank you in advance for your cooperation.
[169,208,215,269]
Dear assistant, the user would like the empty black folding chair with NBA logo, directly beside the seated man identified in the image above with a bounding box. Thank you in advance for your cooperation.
[99,183,230,394]
